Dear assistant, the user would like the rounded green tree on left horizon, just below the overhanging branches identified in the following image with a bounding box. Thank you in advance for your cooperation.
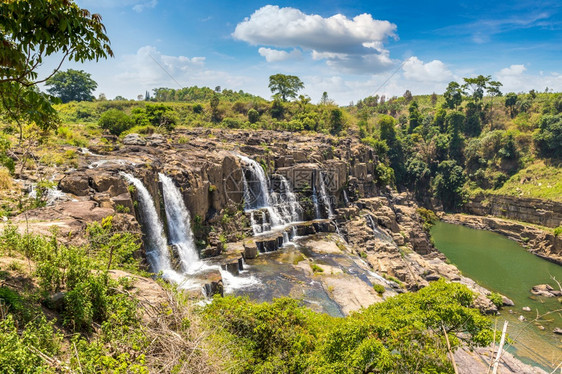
[45,69,97,103]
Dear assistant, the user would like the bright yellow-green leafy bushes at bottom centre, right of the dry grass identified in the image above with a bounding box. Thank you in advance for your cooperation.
[205,281,493,373]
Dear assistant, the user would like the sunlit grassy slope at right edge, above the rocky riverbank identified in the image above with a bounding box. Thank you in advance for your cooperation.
[476,161,562,202]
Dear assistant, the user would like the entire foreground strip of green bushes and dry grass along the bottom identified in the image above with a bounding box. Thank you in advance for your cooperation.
[0,218,493,373]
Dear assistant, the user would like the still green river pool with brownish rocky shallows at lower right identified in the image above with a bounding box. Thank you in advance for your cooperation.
[431,222,562,372]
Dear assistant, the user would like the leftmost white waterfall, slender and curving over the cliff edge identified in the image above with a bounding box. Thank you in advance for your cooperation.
[120,172,172,273]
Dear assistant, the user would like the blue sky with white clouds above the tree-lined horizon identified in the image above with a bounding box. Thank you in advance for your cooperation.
[42,0,562,105]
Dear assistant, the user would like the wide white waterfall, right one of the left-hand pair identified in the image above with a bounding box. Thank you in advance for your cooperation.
[158,173,200,273]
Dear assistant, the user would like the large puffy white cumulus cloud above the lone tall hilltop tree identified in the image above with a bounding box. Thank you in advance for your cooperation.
[232,5,397,73]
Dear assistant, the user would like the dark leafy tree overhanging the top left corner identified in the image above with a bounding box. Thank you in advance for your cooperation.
[0,0,113,140]
